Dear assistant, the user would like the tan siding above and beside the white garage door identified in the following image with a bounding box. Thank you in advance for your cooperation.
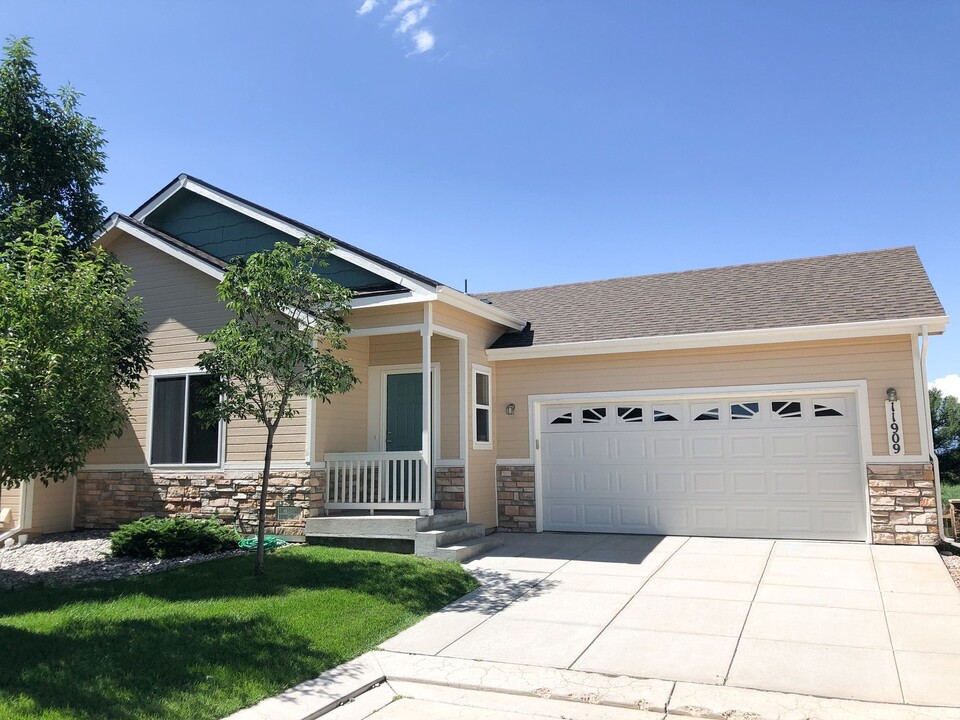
[495,335,920,458]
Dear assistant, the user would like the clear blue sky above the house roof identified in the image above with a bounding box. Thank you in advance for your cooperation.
[7,0,960,392]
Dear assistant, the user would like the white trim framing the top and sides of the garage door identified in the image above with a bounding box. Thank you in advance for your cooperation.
[527,380,872,543]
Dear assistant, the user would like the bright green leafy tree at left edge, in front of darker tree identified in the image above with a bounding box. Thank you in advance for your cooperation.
[0,220,150,487]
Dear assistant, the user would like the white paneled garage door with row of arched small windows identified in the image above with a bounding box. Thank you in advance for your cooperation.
[539,394,866,540]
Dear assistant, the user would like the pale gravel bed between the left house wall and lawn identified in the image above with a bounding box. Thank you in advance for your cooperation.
[0,530,243,590]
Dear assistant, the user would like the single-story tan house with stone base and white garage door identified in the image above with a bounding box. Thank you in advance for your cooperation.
[0,175,948,544]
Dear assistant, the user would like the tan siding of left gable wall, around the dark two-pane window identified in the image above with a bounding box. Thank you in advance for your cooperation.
[87,236,306,465]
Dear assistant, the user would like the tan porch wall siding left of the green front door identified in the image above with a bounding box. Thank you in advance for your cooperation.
[313,337,370,452]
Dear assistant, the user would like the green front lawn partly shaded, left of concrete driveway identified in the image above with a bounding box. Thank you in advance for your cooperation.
[0,547,476,720]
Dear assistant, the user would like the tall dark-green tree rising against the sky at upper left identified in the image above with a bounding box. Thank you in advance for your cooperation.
[0,37,106,248]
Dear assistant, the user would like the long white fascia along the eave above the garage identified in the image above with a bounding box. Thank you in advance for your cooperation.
[486,315,950,360]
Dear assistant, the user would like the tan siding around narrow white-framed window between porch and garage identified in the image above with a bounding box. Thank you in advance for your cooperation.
[433,302,505,528]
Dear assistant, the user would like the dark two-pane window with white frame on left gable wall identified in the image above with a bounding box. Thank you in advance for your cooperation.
[150,375,220,465]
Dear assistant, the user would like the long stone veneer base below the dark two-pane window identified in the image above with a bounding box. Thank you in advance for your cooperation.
[75,470,326,535]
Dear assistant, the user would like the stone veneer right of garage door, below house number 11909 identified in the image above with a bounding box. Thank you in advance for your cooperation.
[867,463,940,545]
